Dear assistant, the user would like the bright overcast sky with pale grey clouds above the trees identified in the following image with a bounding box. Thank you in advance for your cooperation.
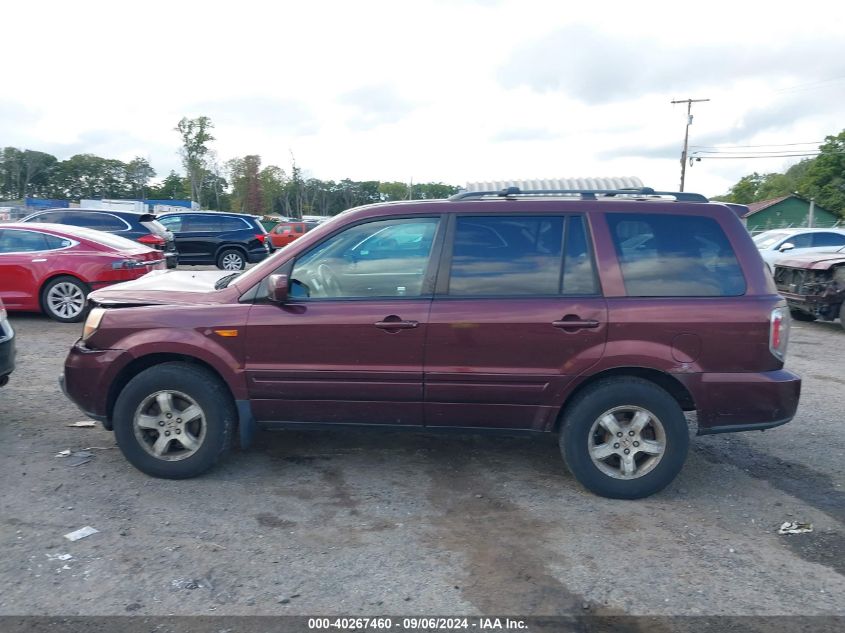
[0,0,845,195]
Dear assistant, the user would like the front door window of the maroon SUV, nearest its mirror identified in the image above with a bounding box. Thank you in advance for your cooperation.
[290,218,439,299]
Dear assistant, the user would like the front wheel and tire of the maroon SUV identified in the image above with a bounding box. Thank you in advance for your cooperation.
[113,362,237,479]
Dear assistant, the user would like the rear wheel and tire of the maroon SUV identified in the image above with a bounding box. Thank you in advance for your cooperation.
[559,377,689,499]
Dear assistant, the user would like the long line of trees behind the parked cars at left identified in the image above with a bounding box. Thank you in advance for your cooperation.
[0,117,458,217]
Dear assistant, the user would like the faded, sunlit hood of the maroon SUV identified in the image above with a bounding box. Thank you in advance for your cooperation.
[90,270,231,306]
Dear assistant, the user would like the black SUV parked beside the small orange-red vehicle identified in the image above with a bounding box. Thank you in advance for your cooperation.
[159,211,271,270]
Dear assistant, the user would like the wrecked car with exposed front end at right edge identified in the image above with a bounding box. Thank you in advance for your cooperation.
[775,248,845,328]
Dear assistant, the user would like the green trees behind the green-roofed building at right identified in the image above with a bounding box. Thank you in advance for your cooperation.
[714,130,845,216]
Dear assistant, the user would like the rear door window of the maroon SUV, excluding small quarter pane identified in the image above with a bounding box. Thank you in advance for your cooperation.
[449,216,564,296]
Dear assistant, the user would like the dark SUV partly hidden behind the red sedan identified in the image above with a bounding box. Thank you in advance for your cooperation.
[21,209,178,268]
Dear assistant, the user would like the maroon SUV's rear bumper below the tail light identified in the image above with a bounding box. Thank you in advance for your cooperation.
[676,369,801,435]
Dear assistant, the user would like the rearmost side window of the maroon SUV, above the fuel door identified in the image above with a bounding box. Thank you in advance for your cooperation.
[607,213,745,297]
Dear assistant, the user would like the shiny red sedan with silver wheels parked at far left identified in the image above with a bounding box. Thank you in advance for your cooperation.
[0,223,165,323]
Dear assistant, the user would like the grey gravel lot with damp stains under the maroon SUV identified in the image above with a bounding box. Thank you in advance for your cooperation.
[0,308,845,615]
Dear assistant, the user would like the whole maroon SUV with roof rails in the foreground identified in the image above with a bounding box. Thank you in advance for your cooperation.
[63,189,801,498]
